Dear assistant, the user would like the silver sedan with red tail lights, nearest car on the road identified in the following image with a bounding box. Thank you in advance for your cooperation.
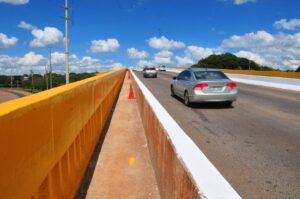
[171,68,238,106]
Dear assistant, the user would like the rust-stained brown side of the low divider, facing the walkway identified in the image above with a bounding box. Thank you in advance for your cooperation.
[133,71,200,199]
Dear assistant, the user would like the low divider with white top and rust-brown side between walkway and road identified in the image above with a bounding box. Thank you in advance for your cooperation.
[131,69,240,199]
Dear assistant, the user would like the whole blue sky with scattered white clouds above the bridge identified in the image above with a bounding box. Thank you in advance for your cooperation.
[0,0,300,74]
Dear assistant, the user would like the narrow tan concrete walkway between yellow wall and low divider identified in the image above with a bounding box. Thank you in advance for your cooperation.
[79,73,160,199]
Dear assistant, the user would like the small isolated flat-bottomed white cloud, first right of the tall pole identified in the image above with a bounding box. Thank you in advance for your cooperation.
[89,39,120,53]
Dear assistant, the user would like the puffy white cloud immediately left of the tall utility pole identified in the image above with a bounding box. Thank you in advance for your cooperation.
[30,27,64,47]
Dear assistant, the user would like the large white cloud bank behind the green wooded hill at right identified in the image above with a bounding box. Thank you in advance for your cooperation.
[221,31,300,70]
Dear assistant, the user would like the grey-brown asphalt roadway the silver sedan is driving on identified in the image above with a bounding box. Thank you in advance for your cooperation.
[135,72,300,199]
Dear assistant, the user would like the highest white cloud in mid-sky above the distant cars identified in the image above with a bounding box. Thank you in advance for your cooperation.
[148,36,185,50]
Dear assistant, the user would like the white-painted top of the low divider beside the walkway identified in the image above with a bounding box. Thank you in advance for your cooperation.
[131,71,241,199]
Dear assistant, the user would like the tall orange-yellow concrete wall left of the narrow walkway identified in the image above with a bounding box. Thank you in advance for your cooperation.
[0,69,126,199]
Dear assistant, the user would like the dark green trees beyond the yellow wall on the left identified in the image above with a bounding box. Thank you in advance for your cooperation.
[0,73,96,93]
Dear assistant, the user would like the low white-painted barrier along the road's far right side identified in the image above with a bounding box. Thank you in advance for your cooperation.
[167,69,300,92]
